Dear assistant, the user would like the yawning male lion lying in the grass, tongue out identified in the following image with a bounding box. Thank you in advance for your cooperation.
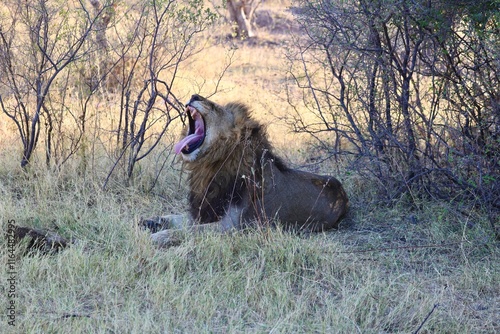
[142,95,349,246]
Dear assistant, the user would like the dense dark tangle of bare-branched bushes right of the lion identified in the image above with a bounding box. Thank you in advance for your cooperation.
[288,0,500,228]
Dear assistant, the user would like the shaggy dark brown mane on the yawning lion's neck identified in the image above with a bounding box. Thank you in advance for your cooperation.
[189,103,288,223]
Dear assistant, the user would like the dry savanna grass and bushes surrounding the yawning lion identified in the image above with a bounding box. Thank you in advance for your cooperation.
[0,0,500,333]
